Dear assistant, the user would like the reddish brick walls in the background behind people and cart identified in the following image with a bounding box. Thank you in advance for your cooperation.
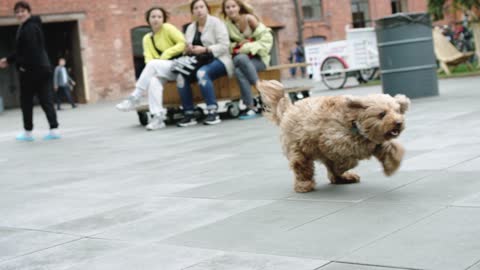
[0,0,436,102]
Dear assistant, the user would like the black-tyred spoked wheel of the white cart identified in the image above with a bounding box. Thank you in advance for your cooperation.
[320,56,347,89]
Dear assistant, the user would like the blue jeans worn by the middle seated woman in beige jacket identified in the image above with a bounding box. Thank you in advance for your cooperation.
[177,59,227,113]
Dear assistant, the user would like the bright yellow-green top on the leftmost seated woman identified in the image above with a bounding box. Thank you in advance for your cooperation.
[143,23,185,63]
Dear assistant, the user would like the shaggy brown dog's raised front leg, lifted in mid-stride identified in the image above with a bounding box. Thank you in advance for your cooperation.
[373,141,405,176]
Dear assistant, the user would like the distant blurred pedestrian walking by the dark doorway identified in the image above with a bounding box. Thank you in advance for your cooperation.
[53,57,77,110]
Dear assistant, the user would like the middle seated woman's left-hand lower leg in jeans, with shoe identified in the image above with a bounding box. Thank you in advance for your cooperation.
[177,74,197,127]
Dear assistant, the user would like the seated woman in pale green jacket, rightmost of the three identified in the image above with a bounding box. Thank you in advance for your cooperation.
[222,0,273,120]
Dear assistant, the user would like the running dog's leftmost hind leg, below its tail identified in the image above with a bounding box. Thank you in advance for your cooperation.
[288,152,315,193]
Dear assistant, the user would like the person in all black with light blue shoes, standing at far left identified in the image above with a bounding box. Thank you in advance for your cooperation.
[0,1,60,141]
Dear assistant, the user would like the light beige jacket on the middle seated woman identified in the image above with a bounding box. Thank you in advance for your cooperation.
[185,15,233,76]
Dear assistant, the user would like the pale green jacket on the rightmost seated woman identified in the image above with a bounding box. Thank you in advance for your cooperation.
[225,20,273,67]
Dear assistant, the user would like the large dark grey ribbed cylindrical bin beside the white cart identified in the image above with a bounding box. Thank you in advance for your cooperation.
[375,13,438,98]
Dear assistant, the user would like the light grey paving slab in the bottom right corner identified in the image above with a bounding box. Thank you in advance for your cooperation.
[341,207,480,270]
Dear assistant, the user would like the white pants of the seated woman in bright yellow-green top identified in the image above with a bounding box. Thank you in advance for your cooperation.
[132,60,177,115]
